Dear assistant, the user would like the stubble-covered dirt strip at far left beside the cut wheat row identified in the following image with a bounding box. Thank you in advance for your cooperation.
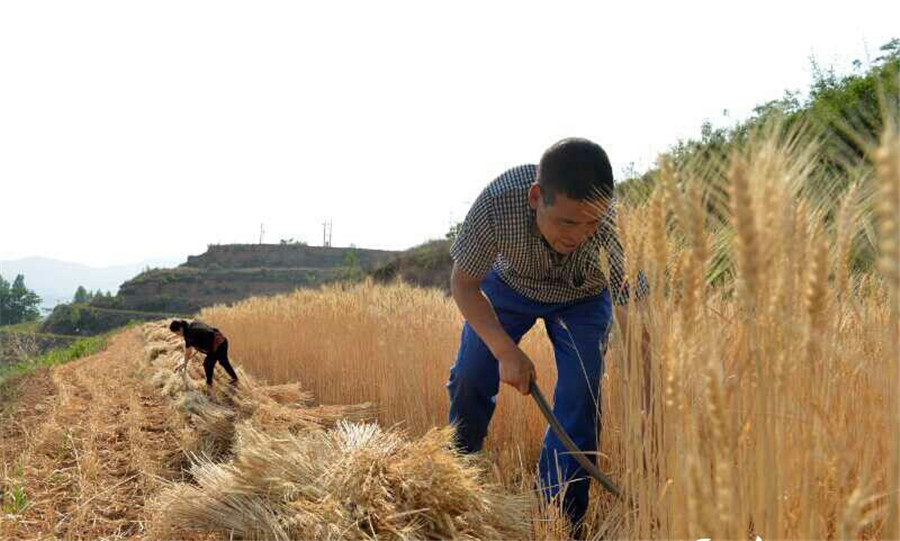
[0,328,185,539]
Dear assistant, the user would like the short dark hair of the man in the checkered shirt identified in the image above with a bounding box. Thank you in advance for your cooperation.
[537,137,613,205]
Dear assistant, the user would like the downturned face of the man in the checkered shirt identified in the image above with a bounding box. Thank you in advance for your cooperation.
[528,183,609,254]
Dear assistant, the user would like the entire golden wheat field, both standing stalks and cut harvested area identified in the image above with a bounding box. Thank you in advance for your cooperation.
[0,122,900,539]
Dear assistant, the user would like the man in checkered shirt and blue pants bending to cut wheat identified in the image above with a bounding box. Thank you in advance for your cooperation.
[447,138,647,529]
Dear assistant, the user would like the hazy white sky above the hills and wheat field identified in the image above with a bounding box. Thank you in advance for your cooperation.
[0,0,900,266]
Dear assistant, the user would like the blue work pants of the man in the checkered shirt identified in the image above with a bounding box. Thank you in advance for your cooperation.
[447,270,612,527]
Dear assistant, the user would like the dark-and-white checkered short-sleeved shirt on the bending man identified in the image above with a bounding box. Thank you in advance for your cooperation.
[450,165,648,305]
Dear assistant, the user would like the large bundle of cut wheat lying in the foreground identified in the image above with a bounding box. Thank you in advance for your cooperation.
[155,423,530,539]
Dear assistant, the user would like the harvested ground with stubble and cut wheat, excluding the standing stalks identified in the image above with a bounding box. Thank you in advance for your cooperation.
[0,322,531,539]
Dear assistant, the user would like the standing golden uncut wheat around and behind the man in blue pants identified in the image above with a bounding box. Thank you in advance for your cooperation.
[200,120,900,539]
